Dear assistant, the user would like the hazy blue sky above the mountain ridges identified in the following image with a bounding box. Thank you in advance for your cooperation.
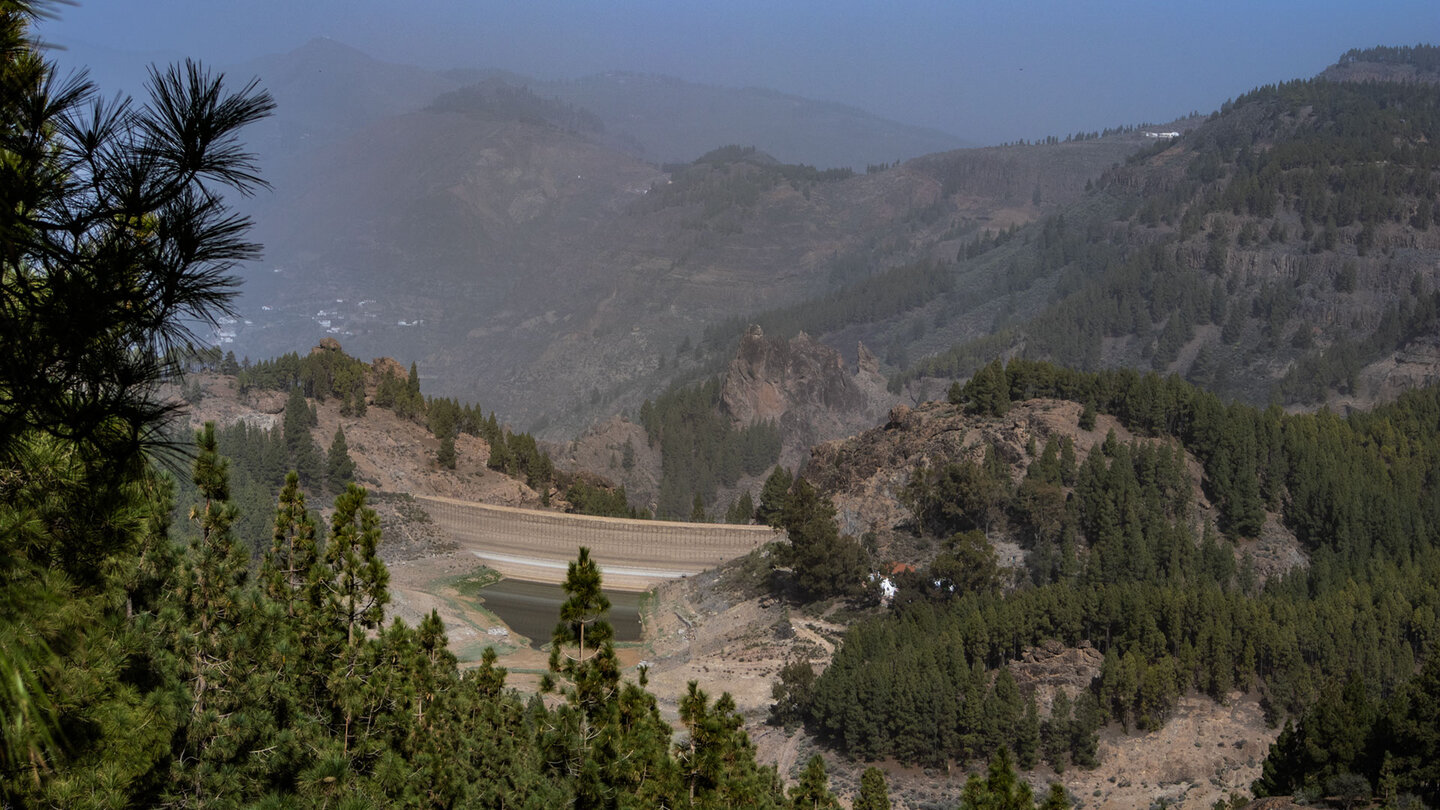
[33,0,1440,143]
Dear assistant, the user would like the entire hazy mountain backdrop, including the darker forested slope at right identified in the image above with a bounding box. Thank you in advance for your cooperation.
[210,40,1436,435]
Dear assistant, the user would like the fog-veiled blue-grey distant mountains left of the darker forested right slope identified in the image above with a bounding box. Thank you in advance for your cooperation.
[208,40,1139,424]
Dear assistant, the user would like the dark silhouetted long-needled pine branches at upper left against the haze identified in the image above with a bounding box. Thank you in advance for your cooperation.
[0,0,275,472]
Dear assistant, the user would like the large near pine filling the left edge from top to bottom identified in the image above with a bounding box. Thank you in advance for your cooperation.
[0,14,274,789]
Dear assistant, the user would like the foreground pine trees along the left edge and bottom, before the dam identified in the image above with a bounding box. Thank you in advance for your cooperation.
[0,0,806,810]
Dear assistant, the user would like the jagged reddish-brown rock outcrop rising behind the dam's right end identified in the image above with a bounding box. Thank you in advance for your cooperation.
[720,326,897,466]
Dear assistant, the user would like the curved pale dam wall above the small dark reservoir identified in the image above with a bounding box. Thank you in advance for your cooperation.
[415,496,776,591]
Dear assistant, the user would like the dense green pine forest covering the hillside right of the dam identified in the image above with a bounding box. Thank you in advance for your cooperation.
[762,360,1440,803]
